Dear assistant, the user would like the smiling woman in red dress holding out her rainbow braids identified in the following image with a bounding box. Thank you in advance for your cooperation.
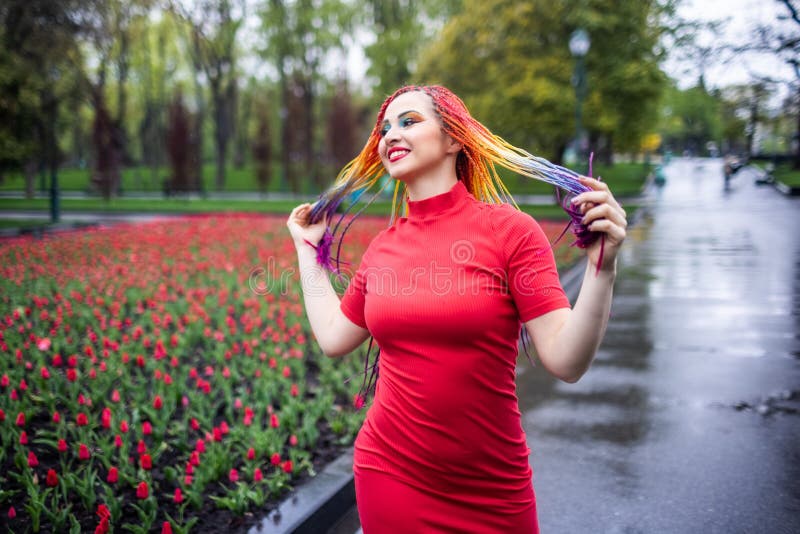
[287,86,627,534]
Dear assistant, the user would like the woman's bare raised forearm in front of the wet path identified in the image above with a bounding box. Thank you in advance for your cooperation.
[546,264,616,382]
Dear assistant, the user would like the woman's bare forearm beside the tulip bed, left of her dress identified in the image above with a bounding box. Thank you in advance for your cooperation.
[297,243,340,354]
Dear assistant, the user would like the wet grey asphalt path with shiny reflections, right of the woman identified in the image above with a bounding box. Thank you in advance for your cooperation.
[518,160,800,534]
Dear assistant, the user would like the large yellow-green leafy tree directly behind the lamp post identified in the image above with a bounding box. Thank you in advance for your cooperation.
[416,0,672,165]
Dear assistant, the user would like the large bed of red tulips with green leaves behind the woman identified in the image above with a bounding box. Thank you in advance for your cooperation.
[0,215,574,533]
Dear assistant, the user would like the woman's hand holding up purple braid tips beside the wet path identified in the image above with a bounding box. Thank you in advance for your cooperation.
[572,176,628,270]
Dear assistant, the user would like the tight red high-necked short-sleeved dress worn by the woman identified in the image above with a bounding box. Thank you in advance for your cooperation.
[341,182,569,534]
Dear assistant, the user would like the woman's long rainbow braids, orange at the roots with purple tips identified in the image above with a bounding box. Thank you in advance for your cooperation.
[311,85,600,273]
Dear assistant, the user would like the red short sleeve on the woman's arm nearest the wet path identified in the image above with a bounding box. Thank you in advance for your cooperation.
[492,204,570,323]
